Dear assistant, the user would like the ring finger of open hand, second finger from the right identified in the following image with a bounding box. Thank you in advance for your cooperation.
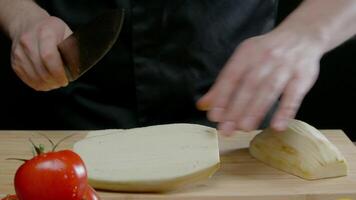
[236,67,290,131]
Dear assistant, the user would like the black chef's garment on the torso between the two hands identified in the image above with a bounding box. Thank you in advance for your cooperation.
[34,0,277,129]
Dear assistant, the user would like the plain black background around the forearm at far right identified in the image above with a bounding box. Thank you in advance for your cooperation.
[278,0,356,140]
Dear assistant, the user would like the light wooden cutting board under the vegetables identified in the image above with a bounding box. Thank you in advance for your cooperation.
[0,130,356,200]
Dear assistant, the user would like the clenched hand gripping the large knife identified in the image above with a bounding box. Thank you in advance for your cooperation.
[11,16,72,91]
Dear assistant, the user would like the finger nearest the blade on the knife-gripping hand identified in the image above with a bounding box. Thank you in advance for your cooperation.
[39,29,68,86]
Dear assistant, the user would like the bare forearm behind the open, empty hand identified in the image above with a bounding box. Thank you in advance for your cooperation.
[275,0,356,52]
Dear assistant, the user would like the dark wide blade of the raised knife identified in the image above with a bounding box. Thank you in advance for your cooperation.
[58,9,124,82]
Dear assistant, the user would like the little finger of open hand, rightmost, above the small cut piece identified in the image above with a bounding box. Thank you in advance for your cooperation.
[271,75,312,131]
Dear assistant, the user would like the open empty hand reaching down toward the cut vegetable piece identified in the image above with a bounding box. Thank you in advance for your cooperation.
[198,31,323,135]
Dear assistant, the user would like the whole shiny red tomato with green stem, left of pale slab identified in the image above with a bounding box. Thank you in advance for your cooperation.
[15,150,88,200]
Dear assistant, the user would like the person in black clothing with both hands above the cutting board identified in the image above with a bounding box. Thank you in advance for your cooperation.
[0,0,356,135]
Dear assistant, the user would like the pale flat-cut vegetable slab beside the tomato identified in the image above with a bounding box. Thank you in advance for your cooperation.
[74,124,220,192]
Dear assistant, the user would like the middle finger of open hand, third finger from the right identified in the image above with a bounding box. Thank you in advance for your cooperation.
[219,65,273,134]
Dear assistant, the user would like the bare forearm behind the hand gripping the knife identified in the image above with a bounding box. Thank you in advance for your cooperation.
[0,0,49,38]
